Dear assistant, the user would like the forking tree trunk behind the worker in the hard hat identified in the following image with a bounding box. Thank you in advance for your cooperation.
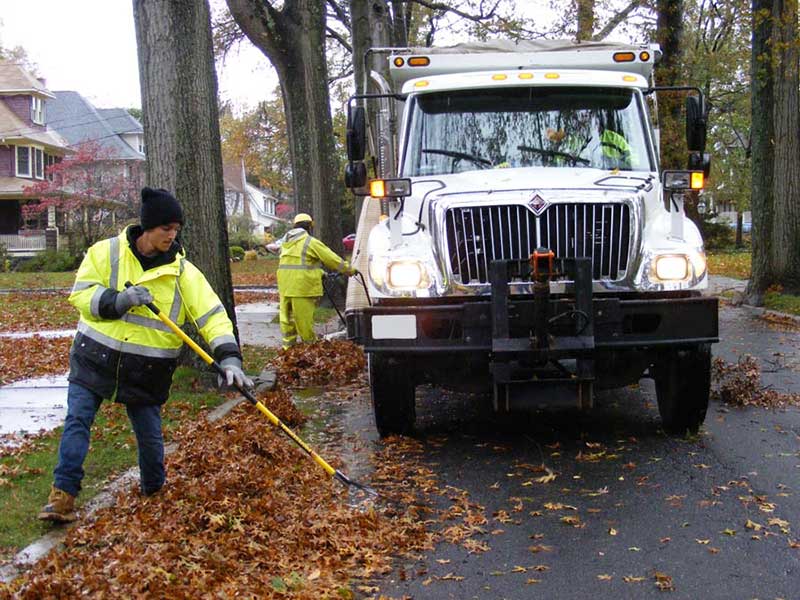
[227,0,342,251]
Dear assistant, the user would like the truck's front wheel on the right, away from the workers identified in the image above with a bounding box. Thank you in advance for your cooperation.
[655,344,711,435]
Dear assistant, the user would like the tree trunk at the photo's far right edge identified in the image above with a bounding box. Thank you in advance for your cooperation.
[747,0,800,306]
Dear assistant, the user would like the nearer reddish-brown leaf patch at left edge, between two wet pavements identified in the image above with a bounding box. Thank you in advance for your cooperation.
[0,335,72,385]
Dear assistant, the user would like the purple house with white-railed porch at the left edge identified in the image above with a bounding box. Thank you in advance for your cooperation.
[0,60,69,256]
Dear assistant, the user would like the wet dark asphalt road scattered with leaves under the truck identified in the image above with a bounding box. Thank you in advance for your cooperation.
[326,308,800,600]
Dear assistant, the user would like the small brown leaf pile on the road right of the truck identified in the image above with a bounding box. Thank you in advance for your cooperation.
[711,354,800,408]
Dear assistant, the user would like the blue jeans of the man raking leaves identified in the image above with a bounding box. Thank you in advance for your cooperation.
[53,382,165,496]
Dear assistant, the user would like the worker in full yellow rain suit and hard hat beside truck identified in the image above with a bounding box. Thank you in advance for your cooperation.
[278,213,355,349]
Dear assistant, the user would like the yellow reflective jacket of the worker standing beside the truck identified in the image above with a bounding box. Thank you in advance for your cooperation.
[278,227,350,298]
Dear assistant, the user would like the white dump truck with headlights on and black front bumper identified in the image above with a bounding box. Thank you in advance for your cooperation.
[345,41,718,435]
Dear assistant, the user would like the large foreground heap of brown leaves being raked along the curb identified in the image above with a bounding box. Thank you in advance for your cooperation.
[0,400,429,598]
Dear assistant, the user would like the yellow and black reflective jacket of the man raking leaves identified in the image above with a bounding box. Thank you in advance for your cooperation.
[69,230,239,404]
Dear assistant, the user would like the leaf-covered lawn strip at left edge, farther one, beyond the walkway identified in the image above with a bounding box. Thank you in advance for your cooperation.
[0,292,78,332]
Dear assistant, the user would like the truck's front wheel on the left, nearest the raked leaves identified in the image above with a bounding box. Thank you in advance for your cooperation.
[368,354,416,437]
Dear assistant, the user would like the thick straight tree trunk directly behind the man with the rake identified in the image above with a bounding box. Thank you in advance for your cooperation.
[133,0,238,336]
